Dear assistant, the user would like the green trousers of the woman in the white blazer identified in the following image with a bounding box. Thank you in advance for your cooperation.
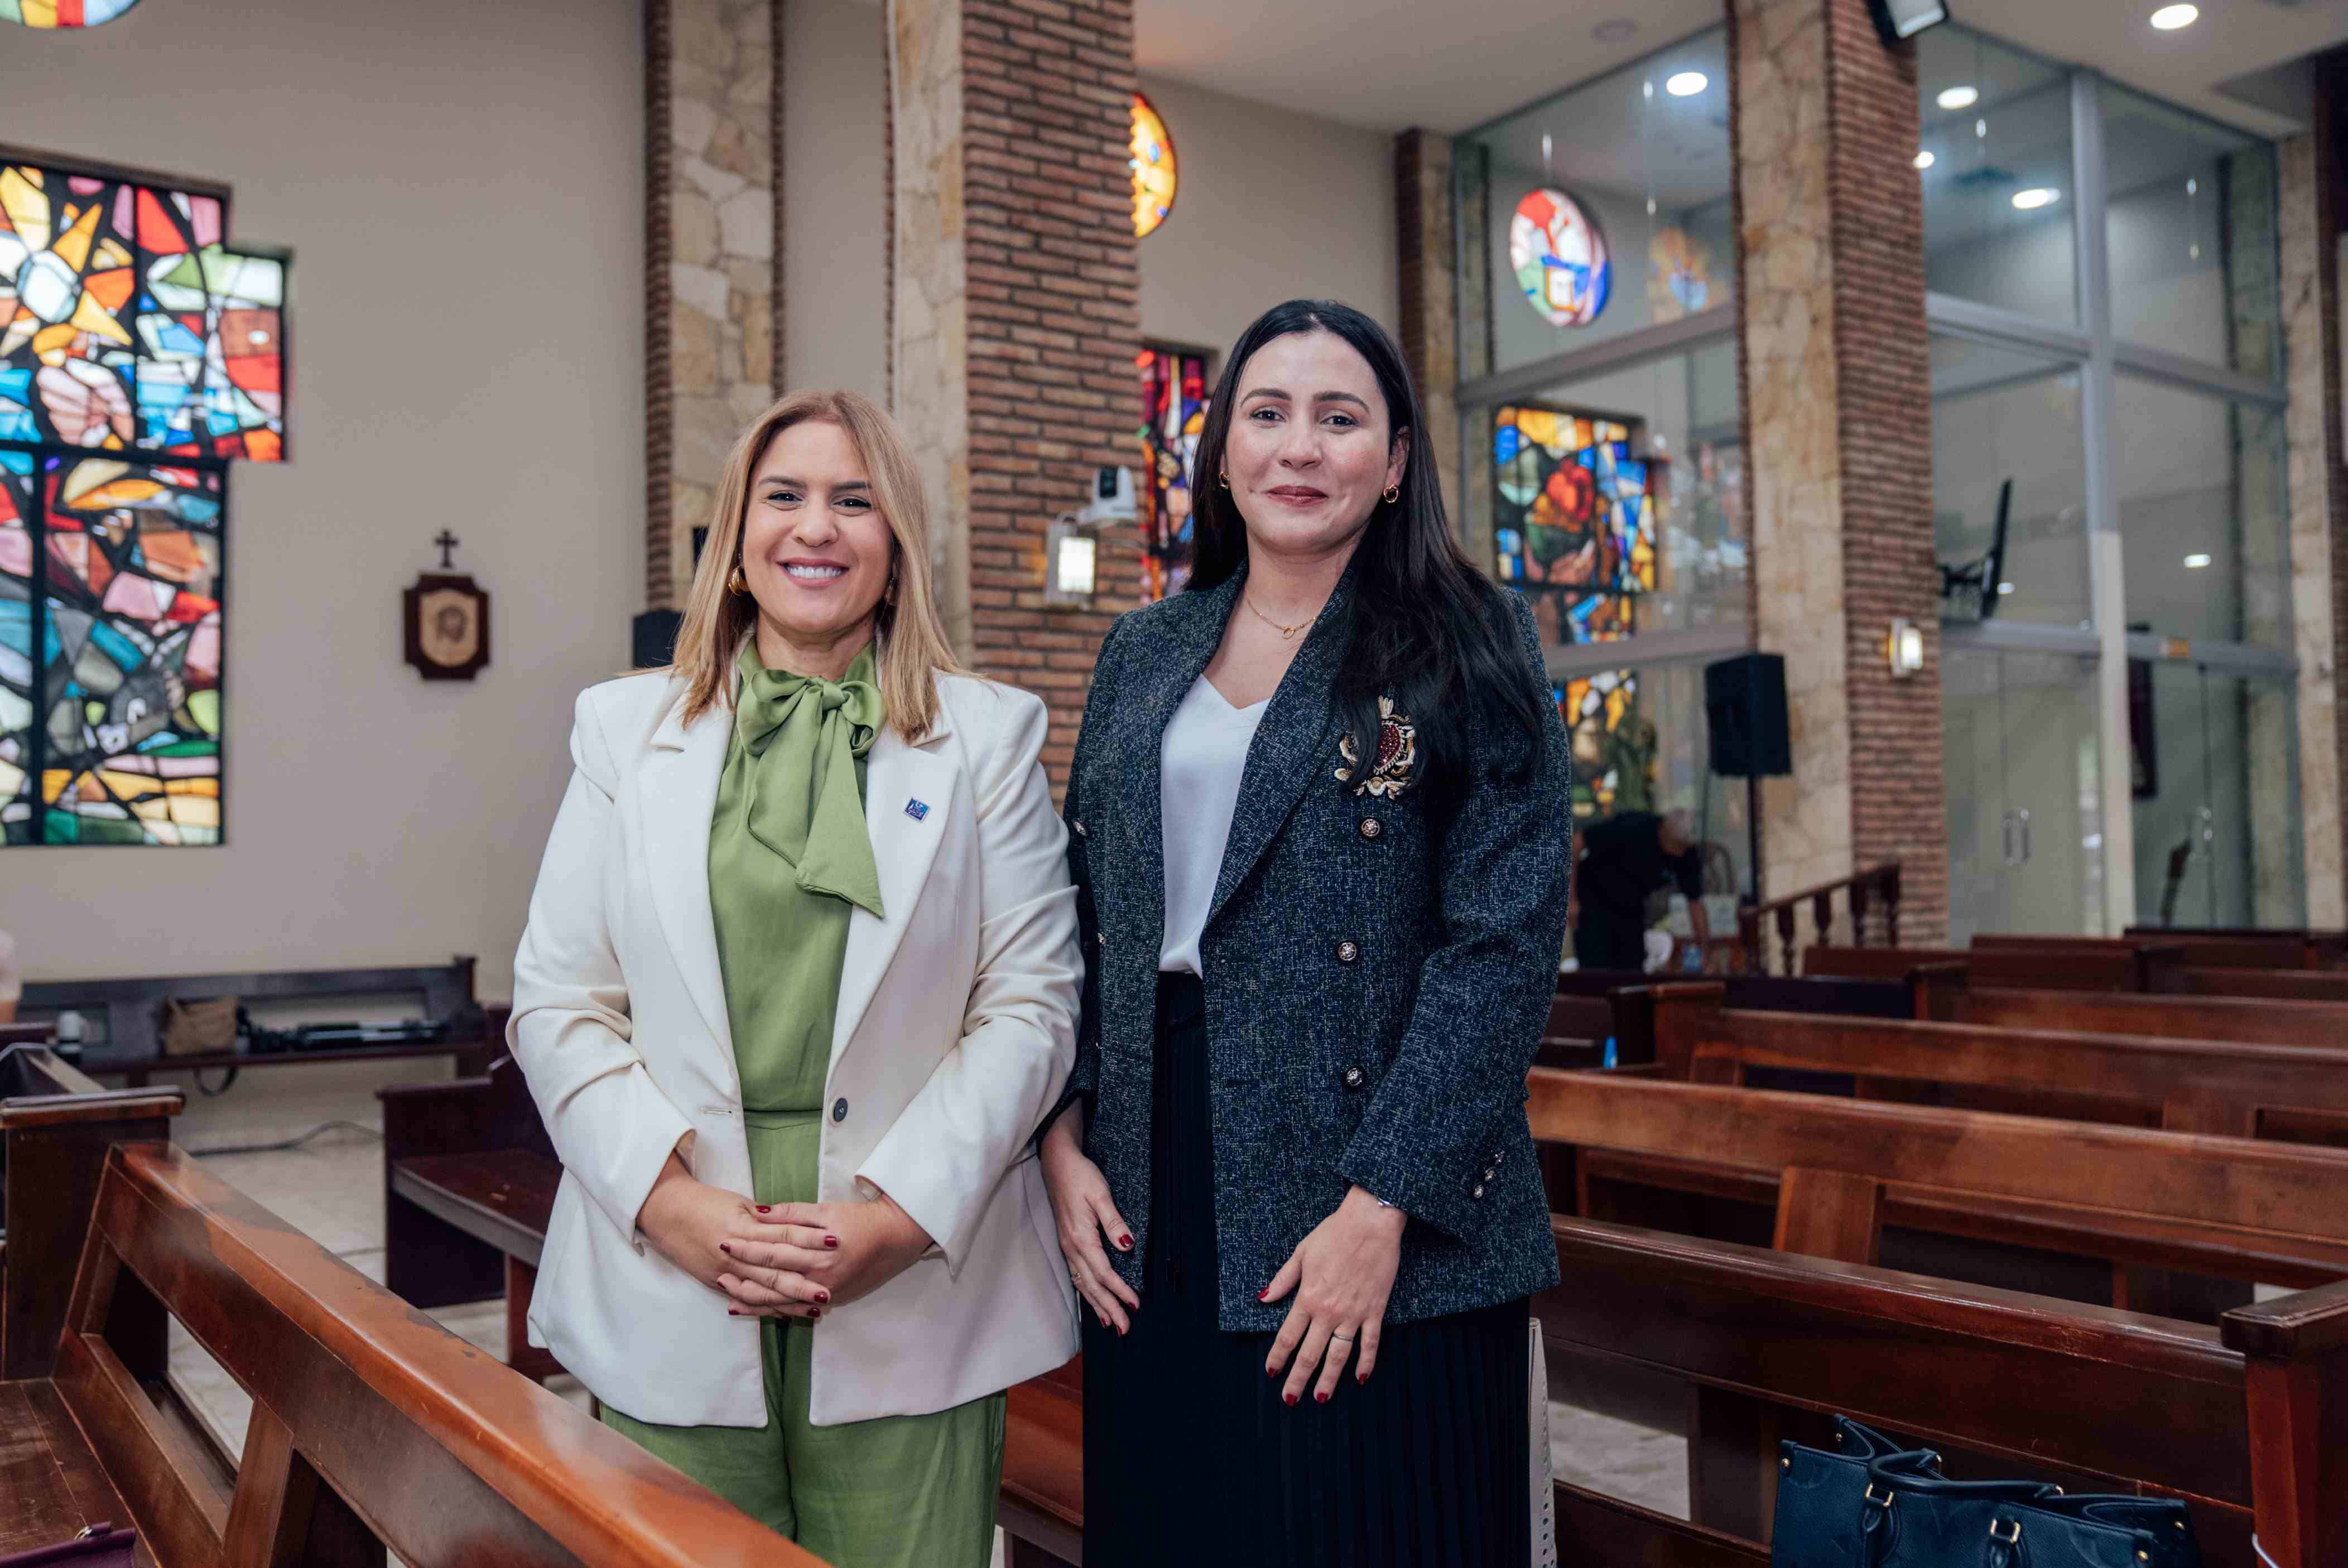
[603,1110,1003,1568]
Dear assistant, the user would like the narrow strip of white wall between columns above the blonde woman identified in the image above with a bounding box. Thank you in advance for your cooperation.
[782,0,888,402]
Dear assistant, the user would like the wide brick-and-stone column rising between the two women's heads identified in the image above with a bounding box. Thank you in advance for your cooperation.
[890,0,1141,781]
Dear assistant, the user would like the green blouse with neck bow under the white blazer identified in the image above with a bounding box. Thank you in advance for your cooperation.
[709,641,885,1110]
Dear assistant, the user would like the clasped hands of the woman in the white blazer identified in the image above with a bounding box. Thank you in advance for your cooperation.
[636,1155,930,1321]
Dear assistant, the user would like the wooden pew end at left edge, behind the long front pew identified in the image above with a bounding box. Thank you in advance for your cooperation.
[0,1046,185,1380]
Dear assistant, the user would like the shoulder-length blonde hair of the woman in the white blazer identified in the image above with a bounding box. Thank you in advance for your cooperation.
[669,392,968,742]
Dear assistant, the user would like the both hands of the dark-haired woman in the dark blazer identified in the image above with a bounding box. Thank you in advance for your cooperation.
[1040,1108,1409,1403]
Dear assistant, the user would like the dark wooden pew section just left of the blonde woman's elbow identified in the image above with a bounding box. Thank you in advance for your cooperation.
[376,1033,564,1378]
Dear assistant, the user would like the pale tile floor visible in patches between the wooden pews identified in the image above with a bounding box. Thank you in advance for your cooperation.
[156,1061,1688,1561]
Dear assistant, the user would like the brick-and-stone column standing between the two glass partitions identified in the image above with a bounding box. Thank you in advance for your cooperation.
[1730,0,1949,944]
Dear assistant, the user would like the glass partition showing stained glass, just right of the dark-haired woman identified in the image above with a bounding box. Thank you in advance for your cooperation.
[1454,28,1752,962]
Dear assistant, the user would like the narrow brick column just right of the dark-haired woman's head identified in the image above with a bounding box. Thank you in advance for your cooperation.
[1395,129,1446,533]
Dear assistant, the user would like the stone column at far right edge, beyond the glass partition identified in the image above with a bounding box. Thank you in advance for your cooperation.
[2280,52,2348,927]
